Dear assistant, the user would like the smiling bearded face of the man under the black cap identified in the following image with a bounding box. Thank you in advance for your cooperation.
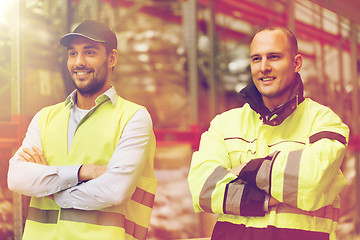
[67,37,115,97]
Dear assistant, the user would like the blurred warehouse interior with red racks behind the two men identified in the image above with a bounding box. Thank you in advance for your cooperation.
[0,0,360,240]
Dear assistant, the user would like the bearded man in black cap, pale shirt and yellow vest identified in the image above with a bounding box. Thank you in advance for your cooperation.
[8,20,157,239]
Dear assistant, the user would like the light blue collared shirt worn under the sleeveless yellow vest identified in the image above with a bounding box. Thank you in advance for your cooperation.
[8,88,155,210]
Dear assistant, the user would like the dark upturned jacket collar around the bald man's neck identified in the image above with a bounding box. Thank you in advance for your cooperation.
[239,73,304,126]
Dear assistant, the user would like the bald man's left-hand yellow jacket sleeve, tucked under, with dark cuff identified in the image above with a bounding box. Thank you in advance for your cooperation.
[188,117,266,216]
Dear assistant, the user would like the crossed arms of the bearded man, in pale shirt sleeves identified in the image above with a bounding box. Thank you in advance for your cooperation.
[8,109,155,210]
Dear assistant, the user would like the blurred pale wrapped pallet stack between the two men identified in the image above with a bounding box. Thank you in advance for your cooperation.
[148,143,201,240]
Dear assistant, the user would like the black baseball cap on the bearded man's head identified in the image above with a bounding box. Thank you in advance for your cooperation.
[60,20,117,49]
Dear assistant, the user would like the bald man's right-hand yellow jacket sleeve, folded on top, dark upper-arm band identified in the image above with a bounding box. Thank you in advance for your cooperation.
[239,108,349,211]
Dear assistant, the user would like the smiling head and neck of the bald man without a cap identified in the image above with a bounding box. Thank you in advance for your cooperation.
[250,30,302,110]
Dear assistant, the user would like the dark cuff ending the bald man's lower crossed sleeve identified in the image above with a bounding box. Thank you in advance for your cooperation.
[240,184,266,217]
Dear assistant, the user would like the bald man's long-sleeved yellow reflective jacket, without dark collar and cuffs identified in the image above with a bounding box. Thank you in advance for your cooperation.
[188,99,349,239]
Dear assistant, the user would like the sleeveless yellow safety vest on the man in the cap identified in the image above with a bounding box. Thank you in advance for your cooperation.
[23,97,157,240]
